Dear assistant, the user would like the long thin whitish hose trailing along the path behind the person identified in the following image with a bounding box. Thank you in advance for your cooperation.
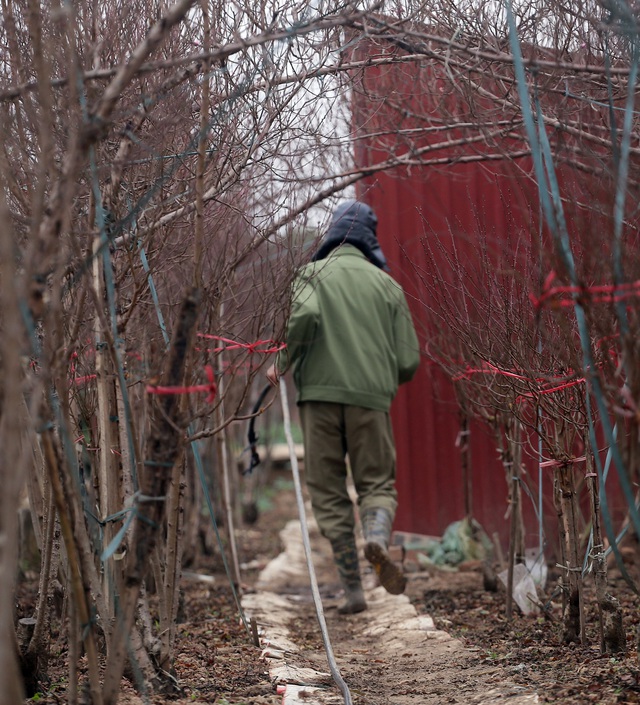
[280,377,352,705]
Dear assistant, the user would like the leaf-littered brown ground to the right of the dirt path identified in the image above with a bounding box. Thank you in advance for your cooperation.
[416,566,640,705]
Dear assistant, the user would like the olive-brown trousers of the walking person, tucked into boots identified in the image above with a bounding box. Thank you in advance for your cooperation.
[299,402,398,541]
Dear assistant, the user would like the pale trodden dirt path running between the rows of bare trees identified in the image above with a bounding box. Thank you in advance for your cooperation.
[243,519,539,705]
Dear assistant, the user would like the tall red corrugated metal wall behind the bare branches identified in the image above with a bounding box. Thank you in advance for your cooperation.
[354,49,624,553]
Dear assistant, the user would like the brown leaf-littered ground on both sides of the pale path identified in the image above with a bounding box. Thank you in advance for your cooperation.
[17,470,640,705]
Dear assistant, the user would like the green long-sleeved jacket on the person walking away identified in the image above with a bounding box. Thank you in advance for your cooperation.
[277,245,420,411]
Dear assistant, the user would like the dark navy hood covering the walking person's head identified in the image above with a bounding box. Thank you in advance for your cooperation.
[312,201,389,271]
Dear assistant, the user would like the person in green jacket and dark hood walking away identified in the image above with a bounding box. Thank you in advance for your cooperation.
[267,201,420,614]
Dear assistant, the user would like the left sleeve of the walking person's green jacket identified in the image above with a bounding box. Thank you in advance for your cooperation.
[276,272,320,374]
